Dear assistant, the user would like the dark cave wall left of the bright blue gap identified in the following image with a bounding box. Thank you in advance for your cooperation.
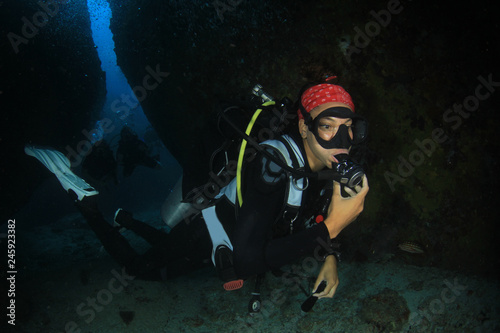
[0,0,106,223]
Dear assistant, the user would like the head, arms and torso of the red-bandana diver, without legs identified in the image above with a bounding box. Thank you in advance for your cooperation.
[202,81,368,298]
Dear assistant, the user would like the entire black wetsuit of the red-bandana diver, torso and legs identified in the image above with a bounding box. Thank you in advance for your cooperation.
[77,130,329,279]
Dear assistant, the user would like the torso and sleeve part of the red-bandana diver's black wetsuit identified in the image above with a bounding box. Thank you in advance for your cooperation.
[217,129,330,279]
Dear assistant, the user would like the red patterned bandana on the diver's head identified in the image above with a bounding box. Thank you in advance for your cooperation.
[298,83,354,119]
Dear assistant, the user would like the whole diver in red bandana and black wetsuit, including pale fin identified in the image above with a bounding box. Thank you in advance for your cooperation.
[25,76,368,298]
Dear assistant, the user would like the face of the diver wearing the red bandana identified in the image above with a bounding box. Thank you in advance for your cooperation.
[299,102,352,172]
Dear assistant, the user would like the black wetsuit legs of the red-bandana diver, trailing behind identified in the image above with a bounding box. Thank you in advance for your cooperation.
[76,195,212,280]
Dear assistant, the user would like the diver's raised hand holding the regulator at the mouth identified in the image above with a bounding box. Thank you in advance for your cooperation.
[325,175,369,238]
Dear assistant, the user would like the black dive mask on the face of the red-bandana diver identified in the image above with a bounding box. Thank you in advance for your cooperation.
[305,106,367,149]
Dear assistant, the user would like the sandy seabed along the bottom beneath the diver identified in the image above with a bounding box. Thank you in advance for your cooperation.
[9,206,500,332]
